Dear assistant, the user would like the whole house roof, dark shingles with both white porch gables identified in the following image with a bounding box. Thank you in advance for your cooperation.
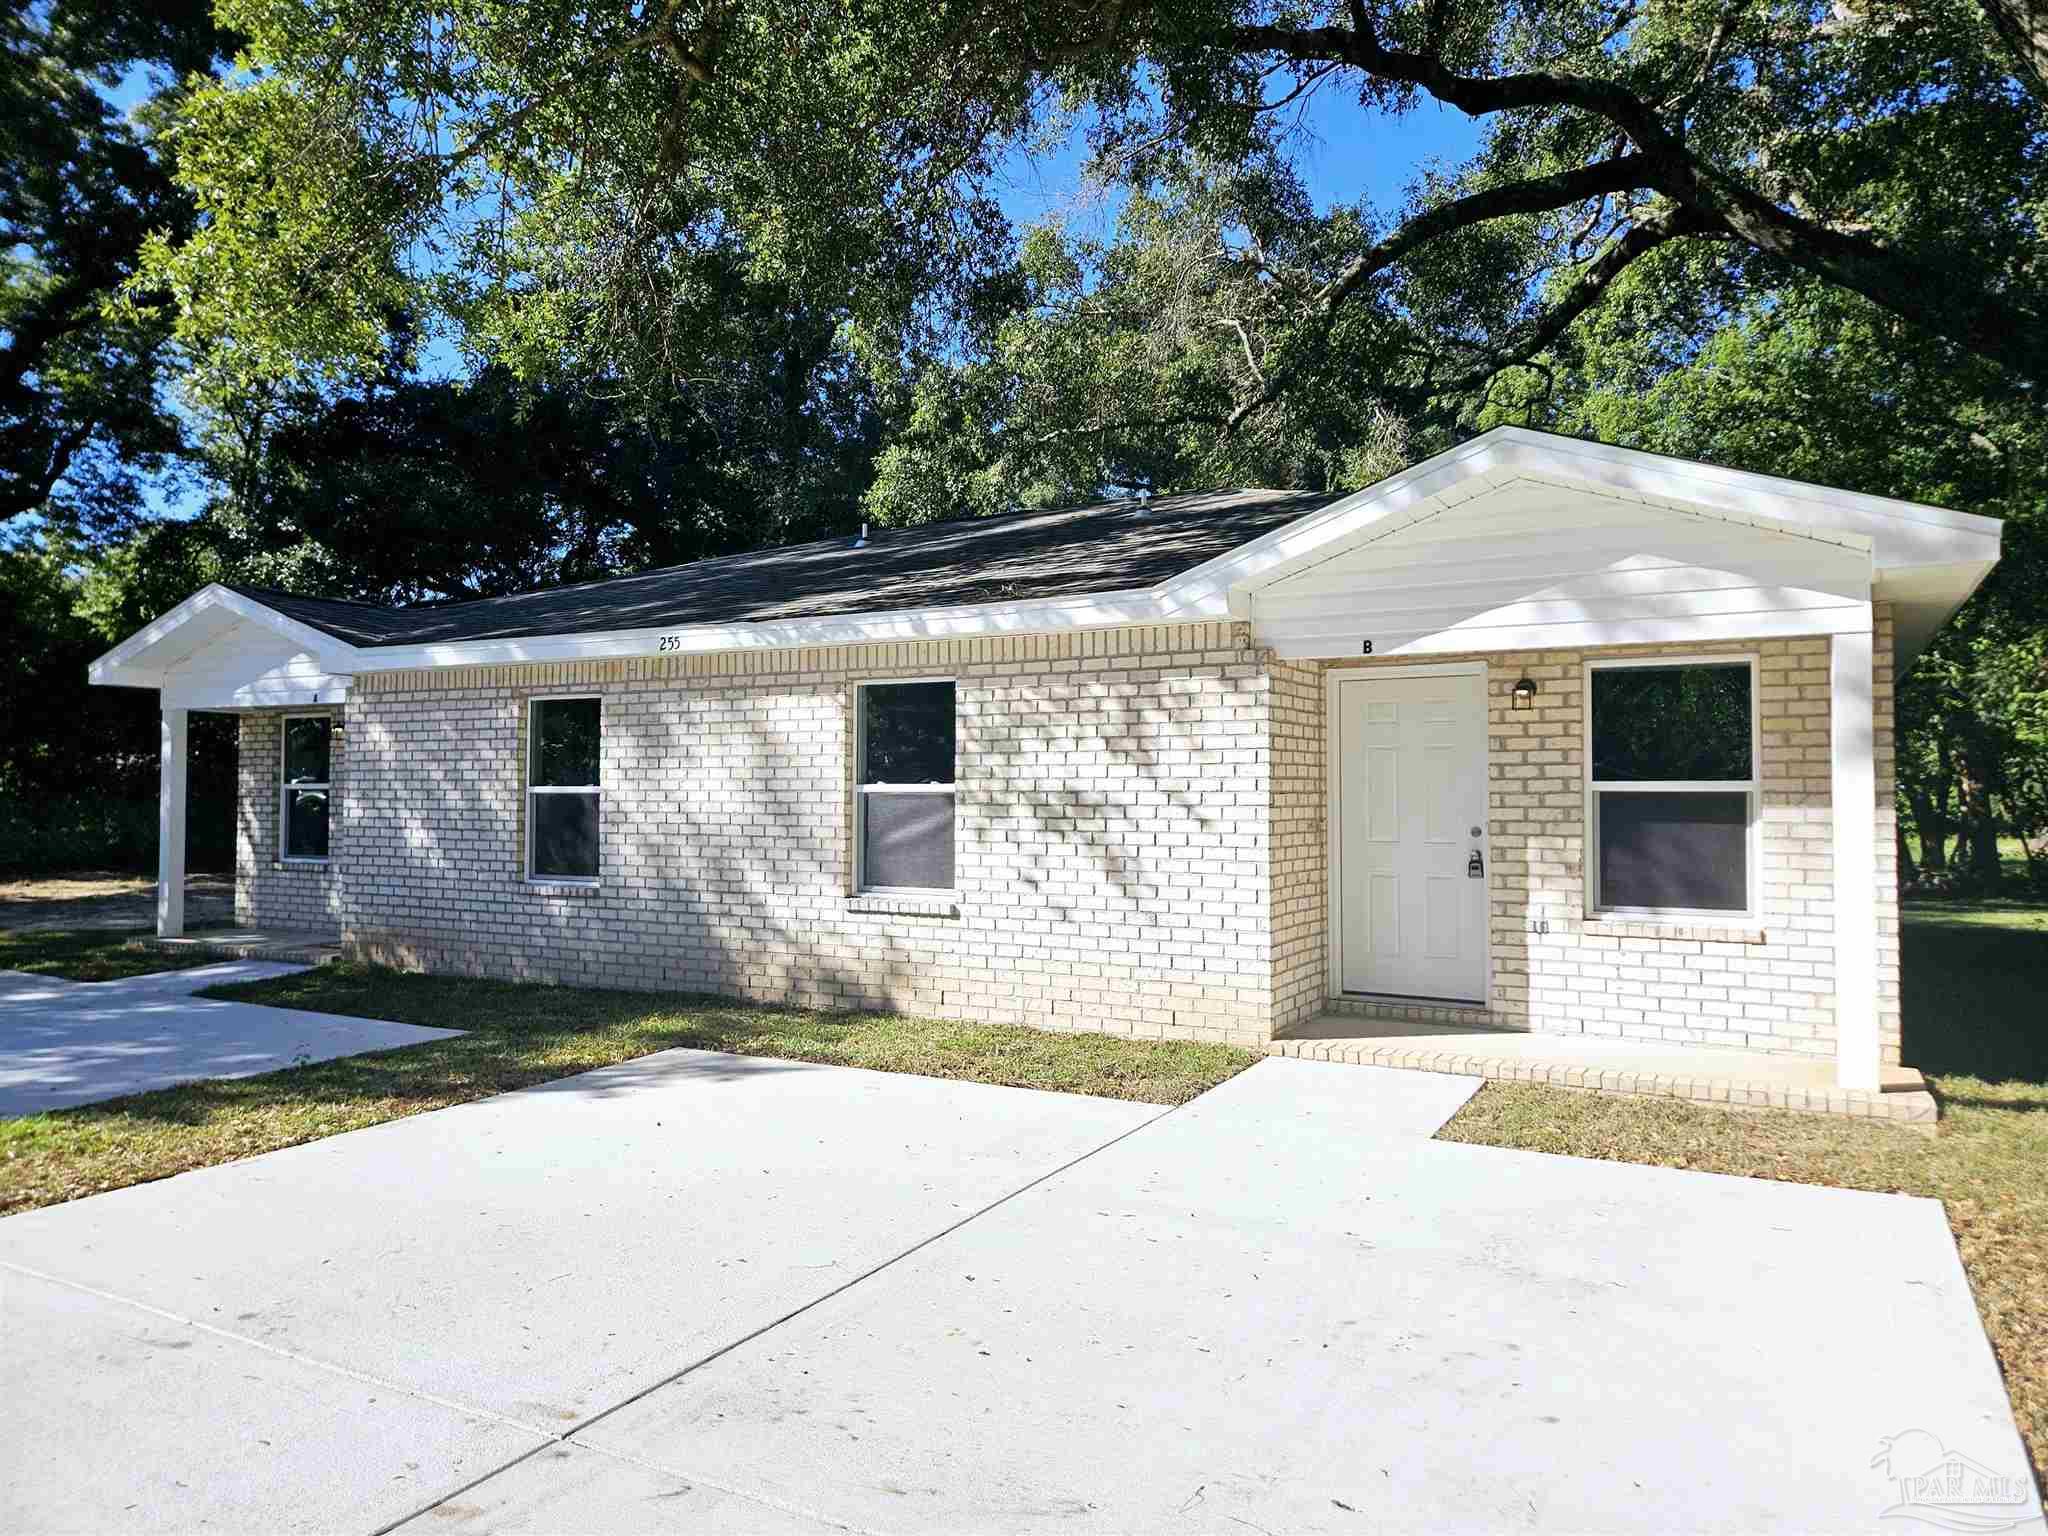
[92,426,2001,692]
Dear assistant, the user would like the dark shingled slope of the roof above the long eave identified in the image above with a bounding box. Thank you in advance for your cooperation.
[236,492,1337,645]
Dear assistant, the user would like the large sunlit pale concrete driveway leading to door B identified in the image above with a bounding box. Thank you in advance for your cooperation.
[0,1051,2040,1534]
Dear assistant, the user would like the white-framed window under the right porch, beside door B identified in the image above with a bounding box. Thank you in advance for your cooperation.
[1587,659,1757,913]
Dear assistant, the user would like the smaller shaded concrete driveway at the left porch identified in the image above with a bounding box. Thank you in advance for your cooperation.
[0,961,461,1116]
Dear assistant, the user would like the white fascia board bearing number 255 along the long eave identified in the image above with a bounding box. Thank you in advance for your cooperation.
[350,590,1196,672]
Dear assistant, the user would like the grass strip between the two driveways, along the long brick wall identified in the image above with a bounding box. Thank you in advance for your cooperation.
[0,965,1257,1212]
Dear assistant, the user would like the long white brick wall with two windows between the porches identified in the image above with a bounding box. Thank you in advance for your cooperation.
[239,625,1272,1044]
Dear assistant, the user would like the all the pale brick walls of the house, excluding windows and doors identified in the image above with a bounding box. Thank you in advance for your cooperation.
[236,614,1898,1061]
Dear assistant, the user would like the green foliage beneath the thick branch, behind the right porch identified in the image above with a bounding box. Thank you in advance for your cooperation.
[1540,270,2048,889]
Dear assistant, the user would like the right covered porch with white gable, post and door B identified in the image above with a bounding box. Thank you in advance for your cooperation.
[1231,430,1997,1120]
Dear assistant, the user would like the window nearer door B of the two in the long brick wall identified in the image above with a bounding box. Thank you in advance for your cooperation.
[854,682,954,891]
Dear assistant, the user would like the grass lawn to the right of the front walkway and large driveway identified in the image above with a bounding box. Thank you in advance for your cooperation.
[1438,903,2048,1485]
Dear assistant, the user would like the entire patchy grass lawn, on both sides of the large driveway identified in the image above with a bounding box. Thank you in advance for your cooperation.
[0,901,2048,1481]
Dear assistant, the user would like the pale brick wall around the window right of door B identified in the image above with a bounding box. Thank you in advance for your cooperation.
[1323,618,1898,1063]
